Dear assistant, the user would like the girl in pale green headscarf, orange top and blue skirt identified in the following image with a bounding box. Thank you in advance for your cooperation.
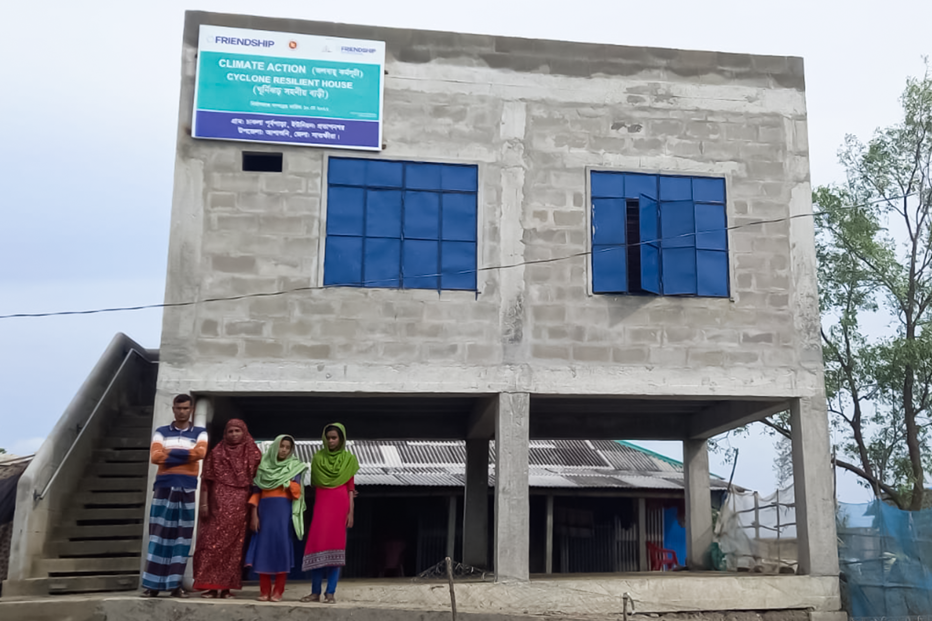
[246,436,307,602]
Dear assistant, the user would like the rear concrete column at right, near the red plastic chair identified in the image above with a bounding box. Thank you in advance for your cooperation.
[683,440,712,569]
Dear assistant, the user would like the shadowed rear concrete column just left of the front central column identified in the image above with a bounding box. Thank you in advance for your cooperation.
[463,439,489,569]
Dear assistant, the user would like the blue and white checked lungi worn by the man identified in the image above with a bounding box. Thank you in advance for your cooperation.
[142,487,195,591]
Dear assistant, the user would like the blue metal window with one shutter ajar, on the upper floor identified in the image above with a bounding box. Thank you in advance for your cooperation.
[590,172,728,297]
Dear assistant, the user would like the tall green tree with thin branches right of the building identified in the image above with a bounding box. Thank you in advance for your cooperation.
[800,64,932,510]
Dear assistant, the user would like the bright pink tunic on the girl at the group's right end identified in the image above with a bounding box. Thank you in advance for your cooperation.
[301,484,350,571]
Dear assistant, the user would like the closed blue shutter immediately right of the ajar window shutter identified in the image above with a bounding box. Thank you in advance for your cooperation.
[660,201,697,295]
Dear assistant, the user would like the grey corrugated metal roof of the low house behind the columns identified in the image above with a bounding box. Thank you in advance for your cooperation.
[260,440,727,490]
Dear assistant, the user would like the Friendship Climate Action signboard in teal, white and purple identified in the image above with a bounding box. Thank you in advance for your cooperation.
[192,25,385,151]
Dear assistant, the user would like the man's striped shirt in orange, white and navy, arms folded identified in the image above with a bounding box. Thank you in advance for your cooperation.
[149,423,207,489]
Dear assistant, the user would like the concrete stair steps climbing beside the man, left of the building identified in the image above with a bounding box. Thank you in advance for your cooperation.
[36,407,152,594]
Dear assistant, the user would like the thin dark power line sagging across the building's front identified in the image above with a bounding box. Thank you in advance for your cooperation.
[0,192,918,319]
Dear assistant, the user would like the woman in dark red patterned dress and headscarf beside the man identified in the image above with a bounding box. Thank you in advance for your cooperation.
[194,418,262,598]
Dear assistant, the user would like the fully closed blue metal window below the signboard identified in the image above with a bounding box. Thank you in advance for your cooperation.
[324,157,478,291]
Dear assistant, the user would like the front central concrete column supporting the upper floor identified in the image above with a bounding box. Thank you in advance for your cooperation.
[495,393,531,582]
